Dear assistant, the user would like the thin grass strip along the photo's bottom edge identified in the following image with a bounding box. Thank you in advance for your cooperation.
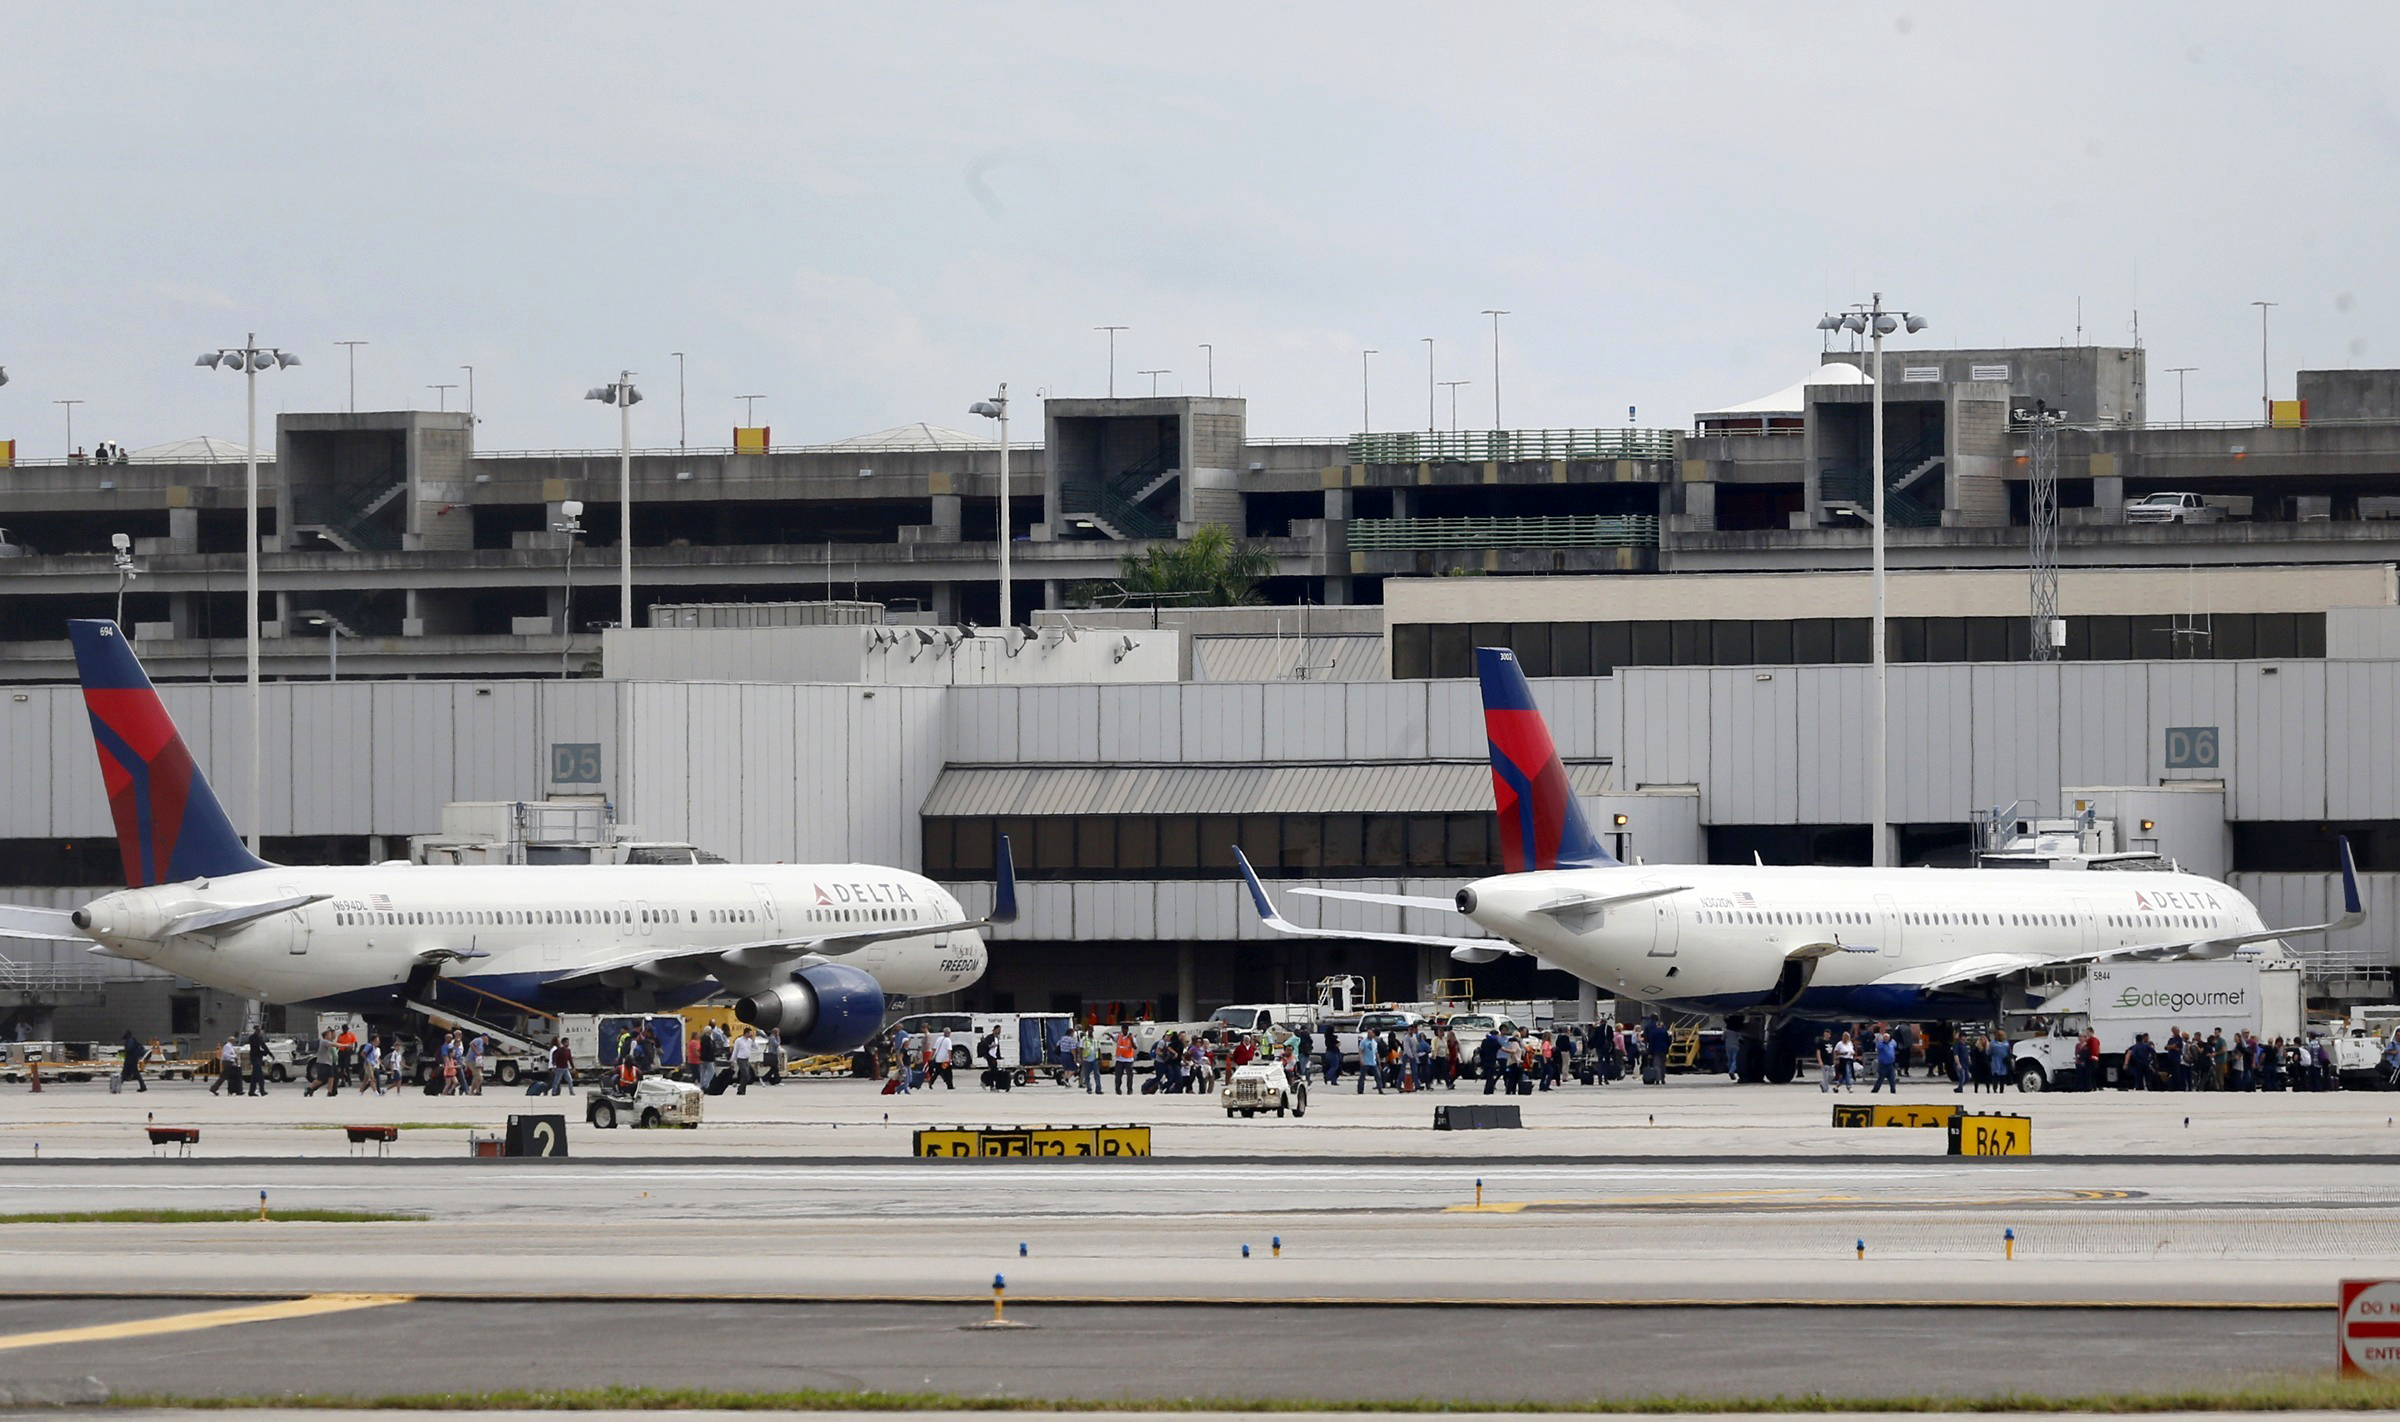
[110,1376,2400,1415]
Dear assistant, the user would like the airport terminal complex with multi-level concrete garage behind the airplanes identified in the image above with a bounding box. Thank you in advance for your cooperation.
[0,348,2400,1035]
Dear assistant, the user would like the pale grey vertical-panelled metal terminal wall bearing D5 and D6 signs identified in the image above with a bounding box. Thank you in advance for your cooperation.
[0,661,2400,883]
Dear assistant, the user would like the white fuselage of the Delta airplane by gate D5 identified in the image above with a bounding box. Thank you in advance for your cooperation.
[79,865,986,1011]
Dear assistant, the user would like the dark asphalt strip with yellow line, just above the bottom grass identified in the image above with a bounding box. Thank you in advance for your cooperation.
[0,1299,2333,1405]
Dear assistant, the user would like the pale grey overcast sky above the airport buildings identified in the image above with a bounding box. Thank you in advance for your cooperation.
[0,0,2400,456]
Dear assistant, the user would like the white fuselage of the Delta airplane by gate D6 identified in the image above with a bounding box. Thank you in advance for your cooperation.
[1469,865,2266,1021]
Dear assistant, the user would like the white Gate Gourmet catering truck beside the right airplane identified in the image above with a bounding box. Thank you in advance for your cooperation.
[2011,958,2304,1091]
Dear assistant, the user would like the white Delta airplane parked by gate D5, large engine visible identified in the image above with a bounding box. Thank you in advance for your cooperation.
[0,622,1018,1052]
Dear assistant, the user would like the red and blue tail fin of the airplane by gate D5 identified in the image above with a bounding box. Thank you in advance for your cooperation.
[67,620,266,889]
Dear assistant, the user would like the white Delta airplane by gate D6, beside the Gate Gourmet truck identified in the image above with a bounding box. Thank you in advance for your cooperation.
[1241,646,2366,1081]
